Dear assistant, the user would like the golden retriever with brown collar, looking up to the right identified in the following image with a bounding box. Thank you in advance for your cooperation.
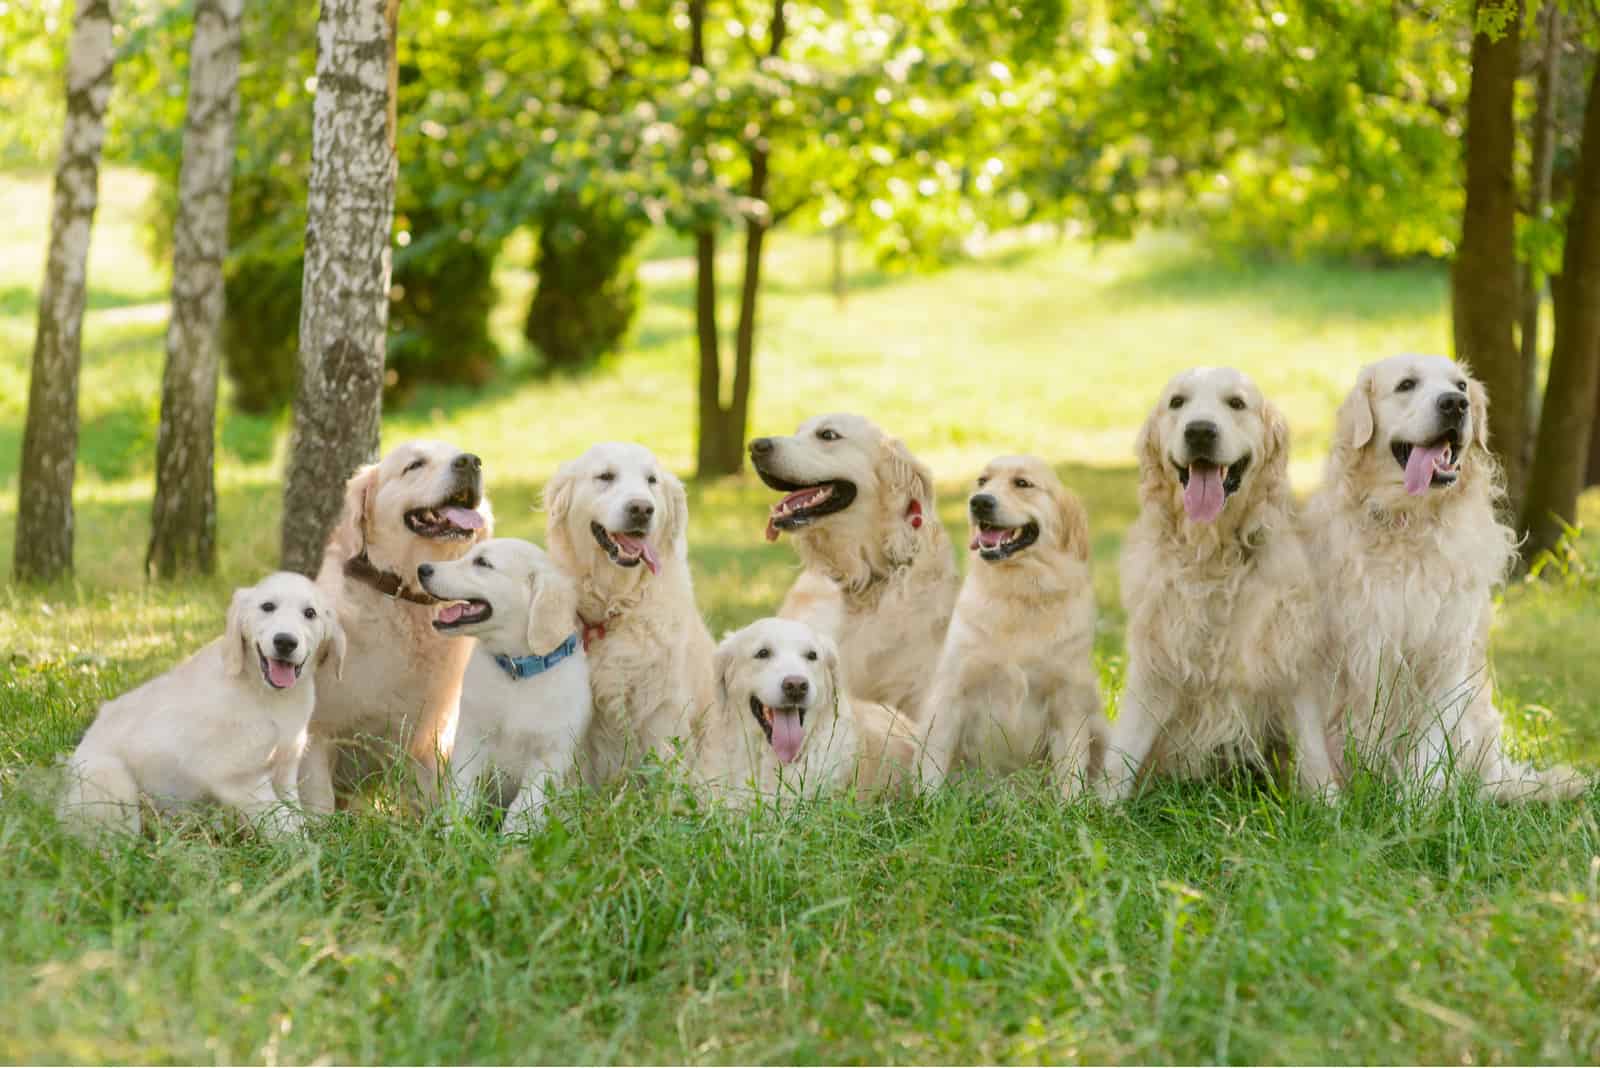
[301,441,493,812]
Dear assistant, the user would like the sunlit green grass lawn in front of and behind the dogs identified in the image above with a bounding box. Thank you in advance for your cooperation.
[9,171,1600,1062]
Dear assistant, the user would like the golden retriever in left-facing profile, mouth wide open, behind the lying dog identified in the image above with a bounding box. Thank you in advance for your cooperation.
[750,414,960,716]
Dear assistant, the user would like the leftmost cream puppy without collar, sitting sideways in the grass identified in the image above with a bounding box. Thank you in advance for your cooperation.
[61,572,344,835]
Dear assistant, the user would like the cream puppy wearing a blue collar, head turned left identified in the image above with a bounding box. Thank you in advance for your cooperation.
[416,537,590,830]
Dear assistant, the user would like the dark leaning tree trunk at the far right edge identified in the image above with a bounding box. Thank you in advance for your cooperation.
[1523,56,1600,560]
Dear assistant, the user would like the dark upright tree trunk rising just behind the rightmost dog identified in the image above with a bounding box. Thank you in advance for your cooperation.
[1451,0,1526,518]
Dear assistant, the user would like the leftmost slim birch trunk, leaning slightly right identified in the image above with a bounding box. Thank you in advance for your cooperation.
[11,0,117,582]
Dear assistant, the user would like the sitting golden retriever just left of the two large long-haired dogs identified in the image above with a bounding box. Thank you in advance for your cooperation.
[920,456,1106,796]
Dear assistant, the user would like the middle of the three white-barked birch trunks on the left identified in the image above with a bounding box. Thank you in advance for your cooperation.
[144,0,245,579]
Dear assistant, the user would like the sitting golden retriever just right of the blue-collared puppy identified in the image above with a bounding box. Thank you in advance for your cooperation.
[544,441,715,783]
